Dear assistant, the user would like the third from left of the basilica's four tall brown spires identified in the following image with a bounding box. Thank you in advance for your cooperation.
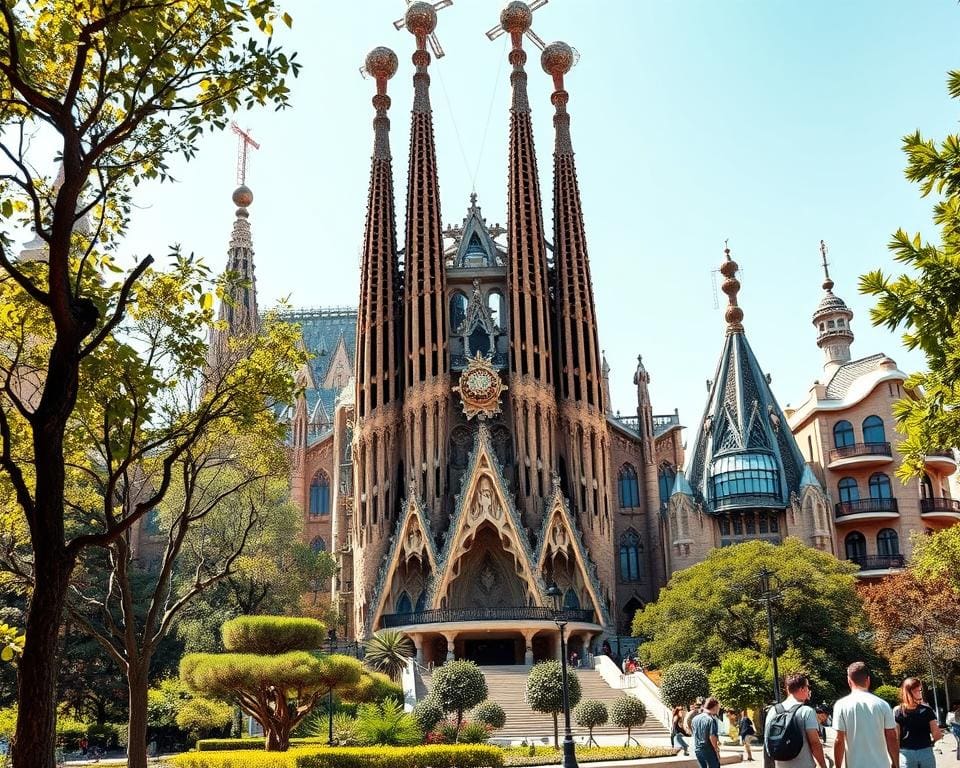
[500,0,556,527]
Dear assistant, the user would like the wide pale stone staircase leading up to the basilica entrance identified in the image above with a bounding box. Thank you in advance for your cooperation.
[417,665,670,741]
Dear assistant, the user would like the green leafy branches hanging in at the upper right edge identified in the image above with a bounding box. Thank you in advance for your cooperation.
[860,71,960,478]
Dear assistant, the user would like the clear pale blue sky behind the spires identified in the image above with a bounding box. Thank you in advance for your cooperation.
[110,0,960,438]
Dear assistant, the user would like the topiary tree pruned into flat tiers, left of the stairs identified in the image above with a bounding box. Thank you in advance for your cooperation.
[180,616,363,752]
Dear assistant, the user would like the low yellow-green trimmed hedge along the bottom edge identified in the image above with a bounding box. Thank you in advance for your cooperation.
[170,744,504,768]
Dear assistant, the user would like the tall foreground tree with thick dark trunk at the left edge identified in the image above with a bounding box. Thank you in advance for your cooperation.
[0,0,299,768]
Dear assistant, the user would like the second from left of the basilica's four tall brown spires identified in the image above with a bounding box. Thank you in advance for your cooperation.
[404,2,450,520]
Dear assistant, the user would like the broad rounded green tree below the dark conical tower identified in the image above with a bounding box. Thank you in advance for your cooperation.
[633,538,877,697]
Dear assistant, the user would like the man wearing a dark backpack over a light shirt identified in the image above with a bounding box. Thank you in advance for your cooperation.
[763,672,827,768]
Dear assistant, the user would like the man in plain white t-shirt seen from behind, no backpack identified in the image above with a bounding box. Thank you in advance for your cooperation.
[833,661,900,768]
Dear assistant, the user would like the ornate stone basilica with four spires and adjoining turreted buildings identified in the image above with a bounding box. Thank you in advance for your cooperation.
[201,1,960,664]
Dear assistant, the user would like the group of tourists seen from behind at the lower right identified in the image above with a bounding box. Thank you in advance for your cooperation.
[670,661,960,768]
